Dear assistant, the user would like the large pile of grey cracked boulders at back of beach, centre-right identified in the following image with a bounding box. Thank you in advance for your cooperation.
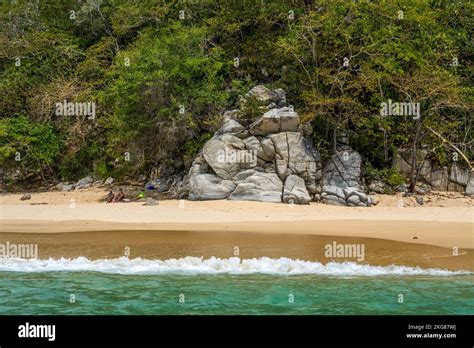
[188,86,371,206]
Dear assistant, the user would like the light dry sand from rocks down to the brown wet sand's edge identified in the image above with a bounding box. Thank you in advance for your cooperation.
[0,189,474,249]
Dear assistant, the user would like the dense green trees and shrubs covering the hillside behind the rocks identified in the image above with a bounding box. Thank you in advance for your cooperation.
[0,0,474,183]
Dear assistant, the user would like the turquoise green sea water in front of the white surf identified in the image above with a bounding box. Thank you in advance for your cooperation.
[0,271,474,315]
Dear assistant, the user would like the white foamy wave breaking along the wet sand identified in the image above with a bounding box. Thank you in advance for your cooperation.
[0,256,473,276]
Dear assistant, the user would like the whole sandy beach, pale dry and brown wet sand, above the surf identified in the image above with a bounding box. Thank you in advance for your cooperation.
[0,189,474,270]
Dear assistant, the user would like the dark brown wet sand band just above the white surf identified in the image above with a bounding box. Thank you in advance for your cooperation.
[0,231,474,271]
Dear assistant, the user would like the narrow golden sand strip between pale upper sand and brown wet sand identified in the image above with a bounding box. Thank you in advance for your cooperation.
[0,219,474,249]
